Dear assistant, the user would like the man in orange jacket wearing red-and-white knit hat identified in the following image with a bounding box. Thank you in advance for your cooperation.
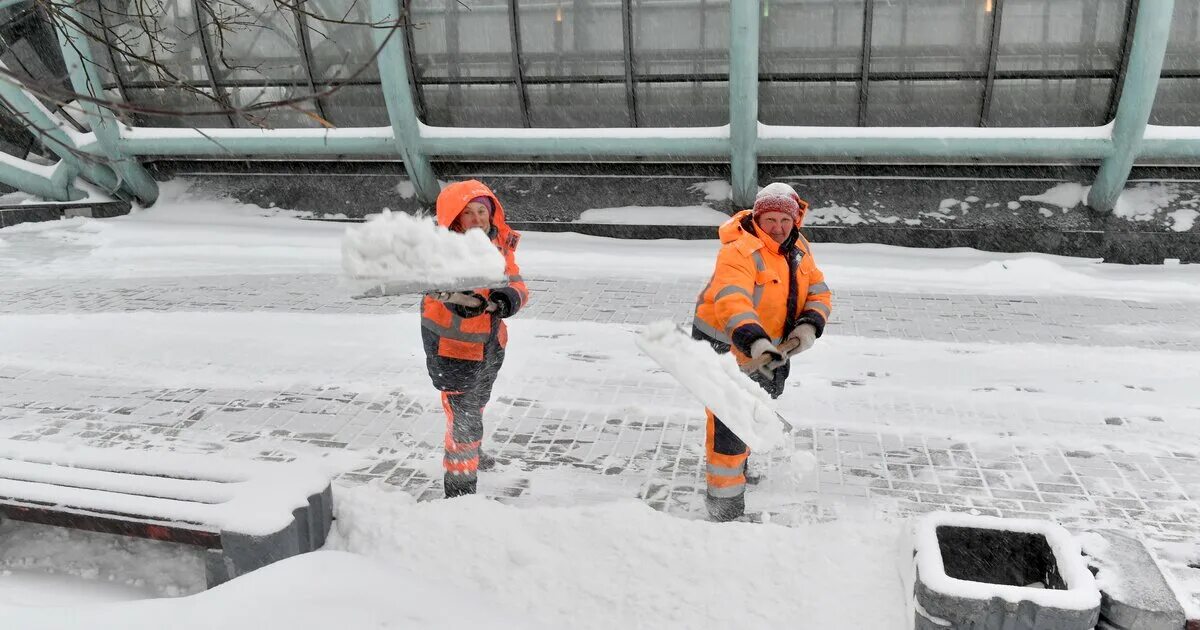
[692,184,832,521]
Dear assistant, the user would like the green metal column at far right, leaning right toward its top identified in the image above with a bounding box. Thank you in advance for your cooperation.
[1087,0,1175,211]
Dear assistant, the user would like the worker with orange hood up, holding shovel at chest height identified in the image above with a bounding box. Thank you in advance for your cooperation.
[421,180,529,498]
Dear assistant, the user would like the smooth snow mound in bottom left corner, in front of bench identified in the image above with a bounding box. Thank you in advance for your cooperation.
[0,551,541,630]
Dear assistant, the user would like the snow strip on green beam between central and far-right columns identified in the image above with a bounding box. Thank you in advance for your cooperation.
[758,122,1112,140]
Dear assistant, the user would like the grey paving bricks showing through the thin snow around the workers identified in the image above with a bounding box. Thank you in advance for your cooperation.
[0,268,1200,604]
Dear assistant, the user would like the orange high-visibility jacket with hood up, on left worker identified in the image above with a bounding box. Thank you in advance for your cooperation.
[421,180,529,361]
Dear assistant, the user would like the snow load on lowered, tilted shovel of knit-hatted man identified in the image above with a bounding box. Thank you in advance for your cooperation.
[637,320,785,451]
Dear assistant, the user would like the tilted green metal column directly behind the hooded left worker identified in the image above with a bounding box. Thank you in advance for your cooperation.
[370,0,442,204]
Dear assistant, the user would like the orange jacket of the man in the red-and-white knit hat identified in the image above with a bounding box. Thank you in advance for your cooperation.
[695,210,832,362]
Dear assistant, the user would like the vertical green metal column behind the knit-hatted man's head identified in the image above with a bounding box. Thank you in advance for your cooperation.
[730,0,762,208]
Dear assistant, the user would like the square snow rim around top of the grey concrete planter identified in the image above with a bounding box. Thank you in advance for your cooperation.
[914,512,1100,611]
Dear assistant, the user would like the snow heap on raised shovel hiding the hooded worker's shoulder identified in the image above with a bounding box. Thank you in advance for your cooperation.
[342,209,504,288]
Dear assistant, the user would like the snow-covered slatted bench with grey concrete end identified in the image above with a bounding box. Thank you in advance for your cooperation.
[0,440,332,587]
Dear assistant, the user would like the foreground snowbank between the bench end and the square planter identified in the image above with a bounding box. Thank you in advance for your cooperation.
[326,486,907,630]
